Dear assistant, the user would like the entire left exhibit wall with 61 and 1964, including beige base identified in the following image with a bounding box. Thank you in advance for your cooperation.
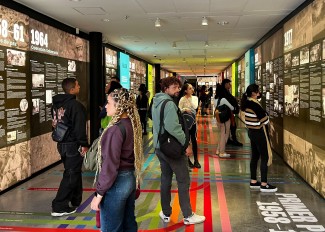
[0,3,89,191]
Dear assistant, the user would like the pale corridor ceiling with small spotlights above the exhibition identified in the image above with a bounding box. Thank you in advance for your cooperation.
[13,0,304,76]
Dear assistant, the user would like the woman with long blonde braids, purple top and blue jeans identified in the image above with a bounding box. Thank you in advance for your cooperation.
[91,88,143,232]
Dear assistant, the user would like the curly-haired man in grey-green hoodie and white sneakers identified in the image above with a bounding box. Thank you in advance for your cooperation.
[152,77,205,225]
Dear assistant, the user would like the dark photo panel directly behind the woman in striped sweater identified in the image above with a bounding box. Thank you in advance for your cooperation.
[255,29,284,154]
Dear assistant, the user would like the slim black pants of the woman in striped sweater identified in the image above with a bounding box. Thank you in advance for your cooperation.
[248,128,269,183]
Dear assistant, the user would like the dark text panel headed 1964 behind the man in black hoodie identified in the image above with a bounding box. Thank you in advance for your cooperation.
[29,19,88,137]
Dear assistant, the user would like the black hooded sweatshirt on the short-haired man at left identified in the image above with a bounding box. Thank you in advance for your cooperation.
[52,94,88,147]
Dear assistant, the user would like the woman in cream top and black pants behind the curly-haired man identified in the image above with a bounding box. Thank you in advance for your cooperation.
[178,83,201,168]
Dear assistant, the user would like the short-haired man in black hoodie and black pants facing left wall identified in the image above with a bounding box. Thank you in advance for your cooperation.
[51,78,88,217]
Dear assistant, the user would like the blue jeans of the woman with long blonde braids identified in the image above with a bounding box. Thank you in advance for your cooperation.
[100,171,138,232]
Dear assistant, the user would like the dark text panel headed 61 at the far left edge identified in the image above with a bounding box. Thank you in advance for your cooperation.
[0,6,31,147]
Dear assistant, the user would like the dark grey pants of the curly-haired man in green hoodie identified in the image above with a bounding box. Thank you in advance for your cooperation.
[156,149,192,217]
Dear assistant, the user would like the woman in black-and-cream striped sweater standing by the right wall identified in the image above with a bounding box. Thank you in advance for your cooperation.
[241,84,278,192]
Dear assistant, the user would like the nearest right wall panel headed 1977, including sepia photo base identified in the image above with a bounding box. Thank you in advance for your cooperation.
[283,0,325,196]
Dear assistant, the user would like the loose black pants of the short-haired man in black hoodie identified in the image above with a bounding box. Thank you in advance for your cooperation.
[52,143,83,212]
